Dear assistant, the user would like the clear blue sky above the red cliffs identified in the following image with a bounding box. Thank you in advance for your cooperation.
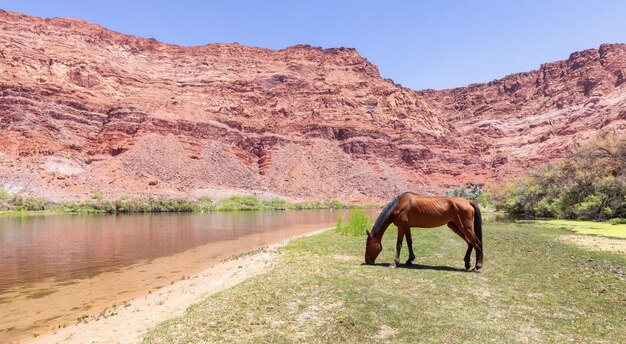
[0,0,626,89]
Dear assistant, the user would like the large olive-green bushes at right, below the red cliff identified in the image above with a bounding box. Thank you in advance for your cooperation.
[487,135,626,223]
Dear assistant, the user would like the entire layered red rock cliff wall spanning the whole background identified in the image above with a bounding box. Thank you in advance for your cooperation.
[0,11,626,202]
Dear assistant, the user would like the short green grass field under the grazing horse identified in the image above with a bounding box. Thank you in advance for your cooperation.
[145,219,626,343]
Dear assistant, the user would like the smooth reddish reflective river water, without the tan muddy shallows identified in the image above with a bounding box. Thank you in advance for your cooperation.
[0,210,360,294]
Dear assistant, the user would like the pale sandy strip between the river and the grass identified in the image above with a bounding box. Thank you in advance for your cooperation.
[20,228,330,343]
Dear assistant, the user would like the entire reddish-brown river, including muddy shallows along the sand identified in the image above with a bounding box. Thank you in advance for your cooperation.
[0,210,366,342]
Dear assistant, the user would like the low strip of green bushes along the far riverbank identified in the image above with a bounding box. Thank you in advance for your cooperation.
[0,189,375,214]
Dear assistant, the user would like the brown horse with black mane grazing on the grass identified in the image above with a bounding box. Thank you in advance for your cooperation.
[365,192,483,271]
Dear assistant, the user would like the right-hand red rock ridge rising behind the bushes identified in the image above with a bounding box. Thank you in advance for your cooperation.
[418,44,626,176]
